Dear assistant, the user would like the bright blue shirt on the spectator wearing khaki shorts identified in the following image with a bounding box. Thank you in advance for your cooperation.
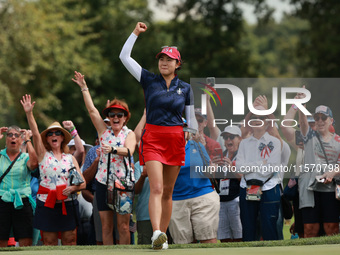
[172,140,214,200]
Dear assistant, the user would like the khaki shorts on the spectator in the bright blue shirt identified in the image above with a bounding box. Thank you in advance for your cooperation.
[169,191,220,244]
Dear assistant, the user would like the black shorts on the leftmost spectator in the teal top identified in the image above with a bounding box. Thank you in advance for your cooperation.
[0,197,33,240]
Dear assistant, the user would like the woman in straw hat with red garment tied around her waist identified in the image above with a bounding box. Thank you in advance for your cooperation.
[20,95,86,245]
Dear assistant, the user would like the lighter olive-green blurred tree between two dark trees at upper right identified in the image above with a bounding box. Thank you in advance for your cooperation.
[242,15,309,78]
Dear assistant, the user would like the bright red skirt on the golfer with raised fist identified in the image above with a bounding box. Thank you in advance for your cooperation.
[139,124,185,166]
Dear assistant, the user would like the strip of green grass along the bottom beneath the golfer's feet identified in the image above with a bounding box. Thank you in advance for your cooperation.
[0,235,340,255]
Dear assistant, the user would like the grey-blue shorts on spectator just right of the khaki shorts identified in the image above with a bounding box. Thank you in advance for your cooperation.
[217,197,242,240]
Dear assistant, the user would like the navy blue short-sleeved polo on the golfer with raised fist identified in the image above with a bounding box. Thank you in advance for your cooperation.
[140,69,194,126]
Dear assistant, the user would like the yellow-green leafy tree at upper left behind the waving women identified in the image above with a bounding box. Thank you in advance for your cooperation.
[0,0,103,135]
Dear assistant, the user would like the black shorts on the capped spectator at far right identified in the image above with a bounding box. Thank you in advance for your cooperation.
[301,191,340,224]
